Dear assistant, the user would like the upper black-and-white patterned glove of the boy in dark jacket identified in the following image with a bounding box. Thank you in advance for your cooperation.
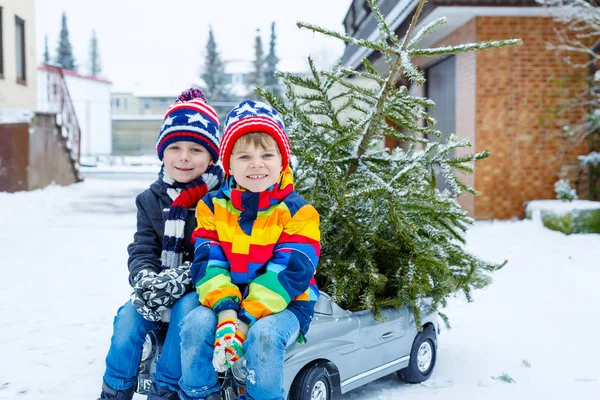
[143,263,192,309]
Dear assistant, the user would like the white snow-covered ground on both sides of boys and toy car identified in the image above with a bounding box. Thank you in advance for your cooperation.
[0,177,600,400]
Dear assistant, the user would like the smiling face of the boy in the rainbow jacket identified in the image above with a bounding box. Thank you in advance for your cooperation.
[229,140,283,193]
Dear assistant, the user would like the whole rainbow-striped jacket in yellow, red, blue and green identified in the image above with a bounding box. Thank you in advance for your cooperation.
[192,167,321,341]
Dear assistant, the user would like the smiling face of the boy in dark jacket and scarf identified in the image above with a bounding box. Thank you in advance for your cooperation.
[163,141,213,183]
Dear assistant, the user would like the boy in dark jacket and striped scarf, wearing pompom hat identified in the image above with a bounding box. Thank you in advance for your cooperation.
[100,88,223,400]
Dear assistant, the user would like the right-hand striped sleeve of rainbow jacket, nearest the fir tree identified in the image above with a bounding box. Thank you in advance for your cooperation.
[240,204,321,325]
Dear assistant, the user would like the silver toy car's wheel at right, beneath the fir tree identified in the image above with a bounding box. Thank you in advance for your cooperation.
[398,326,437,383]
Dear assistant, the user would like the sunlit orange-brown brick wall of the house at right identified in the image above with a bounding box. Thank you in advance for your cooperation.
[475,17,585,219]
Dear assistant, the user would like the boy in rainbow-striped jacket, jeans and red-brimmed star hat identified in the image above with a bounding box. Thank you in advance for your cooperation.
[179,100,320,400]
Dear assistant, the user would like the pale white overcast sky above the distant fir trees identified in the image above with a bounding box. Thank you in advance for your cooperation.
[35,0,351,92]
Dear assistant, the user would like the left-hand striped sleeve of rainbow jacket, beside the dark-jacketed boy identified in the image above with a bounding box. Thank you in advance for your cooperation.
[192,197,242,314]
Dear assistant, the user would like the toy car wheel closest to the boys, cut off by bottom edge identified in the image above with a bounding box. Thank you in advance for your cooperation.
[288,365,333,400]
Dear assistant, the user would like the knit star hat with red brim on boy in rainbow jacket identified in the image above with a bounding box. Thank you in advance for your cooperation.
[220,100,291,174]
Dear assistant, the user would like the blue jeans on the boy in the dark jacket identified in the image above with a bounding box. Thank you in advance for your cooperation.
[104,292,200,391]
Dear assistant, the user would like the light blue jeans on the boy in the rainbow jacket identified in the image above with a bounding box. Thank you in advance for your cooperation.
[179,307,300,400]
